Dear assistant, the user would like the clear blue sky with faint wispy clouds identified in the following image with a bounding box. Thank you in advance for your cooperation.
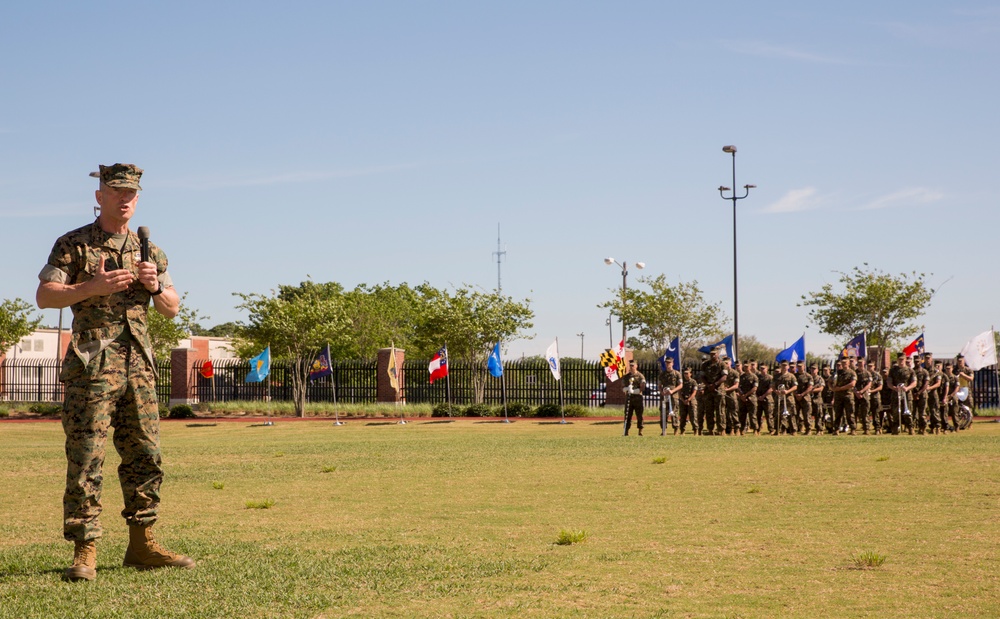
[0,0,1000,357]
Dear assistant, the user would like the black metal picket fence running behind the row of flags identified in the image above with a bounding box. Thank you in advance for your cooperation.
[0,358,1000,407]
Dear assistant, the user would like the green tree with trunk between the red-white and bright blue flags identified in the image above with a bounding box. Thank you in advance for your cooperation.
[415,285,535,403]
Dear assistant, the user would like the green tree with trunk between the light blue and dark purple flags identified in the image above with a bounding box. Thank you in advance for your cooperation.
[233,282,350,417]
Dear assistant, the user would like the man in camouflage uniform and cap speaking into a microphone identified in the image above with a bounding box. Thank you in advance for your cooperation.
[36,164,194,580]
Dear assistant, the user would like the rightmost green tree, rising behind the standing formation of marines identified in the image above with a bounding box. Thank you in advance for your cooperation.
[798,262,934,348]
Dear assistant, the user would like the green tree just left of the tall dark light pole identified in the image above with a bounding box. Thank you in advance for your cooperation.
[598,275,727,350]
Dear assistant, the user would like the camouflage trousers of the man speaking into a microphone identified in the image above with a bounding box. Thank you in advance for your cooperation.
[62,338,163,541]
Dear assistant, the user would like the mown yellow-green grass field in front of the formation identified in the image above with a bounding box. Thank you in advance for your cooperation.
[0,419,1000,619]
